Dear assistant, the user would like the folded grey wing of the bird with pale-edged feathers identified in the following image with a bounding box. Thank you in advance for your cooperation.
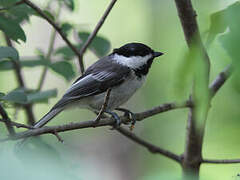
[52,59,131,109]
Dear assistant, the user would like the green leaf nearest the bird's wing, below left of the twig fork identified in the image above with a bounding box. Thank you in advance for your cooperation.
[50,61,75,81]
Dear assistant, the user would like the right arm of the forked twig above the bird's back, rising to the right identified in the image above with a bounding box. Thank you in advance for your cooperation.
[78,0,117,72]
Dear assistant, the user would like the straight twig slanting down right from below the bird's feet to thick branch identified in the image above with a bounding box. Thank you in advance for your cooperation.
[116,127,181,162]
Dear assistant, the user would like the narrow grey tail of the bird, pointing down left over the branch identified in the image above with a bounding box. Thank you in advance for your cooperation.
[33,108,63,128]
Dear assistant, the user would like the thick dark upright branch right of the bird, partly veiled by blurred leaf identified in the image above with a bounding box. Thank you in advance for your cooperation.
[175,0,210,179]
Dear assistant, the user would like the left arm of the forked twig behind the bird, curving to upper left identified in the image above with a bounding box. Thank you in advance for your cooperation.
[23,0,84,73]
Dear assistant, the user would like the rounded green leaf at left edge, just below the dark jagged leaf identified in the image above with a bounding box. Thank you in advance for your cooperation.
[0,46,19,61]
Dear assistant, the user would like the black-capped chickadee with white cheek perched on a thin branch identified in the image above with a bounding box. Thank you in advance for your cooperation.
[33,42,163,128]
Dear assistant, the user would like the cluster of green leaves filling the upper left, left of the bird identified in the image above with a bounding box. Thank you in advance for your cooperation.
[0,0,111,108]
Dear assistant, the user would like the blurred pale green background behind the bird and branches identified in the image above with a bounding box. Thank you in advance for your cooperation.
[0,0,240,180]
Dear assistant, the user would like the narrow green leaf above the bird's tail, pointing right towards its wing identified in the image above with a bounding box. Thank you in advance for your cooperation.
[27,89,57,103]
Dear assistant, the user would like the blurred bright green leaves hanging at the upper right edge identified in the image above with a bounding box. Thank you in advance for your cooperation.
[207,1,240,92]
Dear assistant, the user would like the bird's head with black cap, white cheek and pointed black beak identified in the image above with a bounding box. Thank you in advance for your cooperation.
[112,43,163,75]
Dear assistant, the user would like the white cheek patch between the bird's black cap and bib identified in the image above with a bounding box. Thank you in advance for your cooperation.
[113,54,152,69]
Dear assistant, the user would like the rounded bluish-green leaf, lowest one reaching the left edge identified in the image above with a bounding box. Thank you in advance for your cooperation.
[1,89,27,104]
